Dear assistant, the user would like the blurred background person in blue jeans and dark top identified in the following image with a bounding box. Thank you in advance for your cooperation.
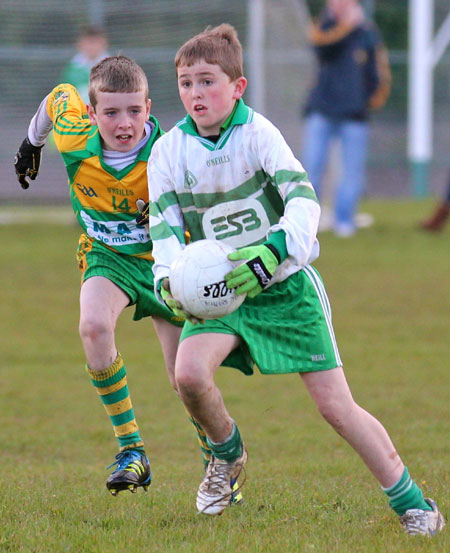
[302,0,391,237]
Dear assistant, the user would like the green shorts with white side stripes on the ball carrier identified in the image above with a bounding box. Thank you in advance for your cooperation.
[180,266,342,374]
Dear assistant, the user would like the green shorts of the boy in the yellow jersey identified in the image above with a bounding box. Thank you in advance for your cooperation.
[77,234,184,326]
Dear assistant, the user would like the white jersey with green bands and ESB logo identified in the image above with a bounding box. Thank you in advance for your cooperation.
[147,100,320,298]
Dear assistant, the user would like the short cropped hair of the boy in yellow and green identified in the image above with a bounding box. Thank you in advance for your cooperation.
[89,56,148,108]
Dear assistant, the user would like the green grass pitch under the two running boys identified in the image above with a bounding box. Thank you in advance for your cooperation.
[0,201,450,553]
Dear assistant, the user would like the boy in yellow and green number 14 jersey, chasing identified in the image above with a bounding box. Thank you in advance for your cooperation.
[15,56,212,495]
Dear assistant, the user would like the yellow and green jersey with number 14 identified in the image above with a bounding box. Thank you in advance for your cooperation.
[46,84,162,259]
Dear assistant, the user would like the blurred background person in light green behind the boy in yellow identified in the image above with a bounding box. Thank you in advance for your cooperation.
[61,25,109,104]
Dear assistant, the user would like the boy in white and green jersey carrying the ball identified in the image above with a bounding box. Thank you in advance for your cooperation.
[148,24,444,535]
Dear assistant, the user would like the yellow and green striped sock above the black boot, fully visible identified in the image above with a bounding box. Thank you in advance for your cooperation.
[86,353,144,451]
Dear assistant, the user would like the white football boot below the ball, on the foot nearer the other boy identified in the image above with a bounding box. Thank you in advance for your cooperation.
[197,446,247,515]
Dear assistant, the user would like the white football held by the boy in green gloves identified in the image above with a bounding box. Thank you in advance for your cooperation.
[169,240,246,319]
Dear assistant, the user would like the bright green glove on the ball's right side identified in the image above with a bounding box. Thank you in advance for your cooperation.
[225,244,280,298]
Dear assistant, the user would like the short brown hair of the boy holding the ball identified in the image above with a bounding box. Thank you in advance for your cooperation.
[175,23,244,81]
